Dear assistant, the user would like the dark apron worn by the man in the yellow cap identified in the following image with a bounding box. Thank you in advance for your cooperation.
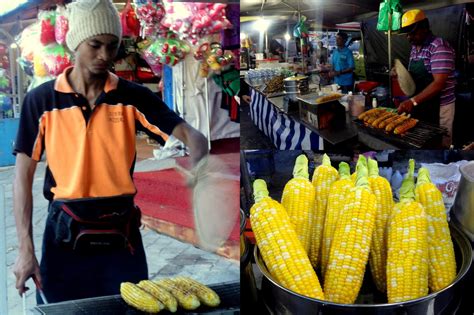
[408,60,440,125]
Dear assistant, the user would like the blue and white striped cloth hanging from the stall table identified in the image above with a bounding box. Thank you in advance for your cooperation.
[250,89,323,150]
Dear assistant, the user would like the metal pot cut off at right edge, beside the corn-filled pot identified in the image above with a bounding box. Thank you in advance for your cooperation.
[452,161,474,242]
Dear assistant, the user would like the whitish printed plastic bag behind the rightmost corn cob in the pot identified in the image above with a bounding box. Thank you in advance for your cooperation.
[421,161,468,213]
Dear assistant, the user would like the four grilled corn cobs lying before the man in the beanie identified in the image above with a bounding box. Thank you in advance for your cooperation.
[120,277,220,313]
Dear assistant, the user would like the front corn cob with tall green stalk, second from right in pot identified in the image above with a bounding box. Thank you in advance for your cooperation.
[387,160,428,303]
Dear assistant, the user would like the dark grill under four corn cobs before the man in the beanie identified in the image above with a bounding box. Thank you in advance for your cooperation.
[31,282,240,315]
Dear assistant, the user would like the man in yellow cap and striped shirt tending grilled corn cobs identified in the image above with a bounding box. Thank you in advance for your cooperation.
[398,9,456,147]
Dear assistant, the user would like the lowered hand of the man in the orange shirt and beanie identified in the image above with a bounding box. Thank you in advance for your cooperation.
[13,251,42,296]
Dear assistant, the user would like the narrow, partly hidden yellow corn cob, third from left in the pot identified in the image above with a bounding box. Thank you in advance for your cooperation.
[309,154,339,268]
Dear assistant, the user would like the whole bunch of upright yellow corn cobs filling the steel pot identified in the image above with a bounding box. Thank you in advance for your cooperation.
[250,154,456,304]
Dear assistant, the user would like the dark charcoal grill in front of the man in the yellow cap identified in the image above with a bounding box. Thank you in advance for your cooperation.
[354,119,447,149]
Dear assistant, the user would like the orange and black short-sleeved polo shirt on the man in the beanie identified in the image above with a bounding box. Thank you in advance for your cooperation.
[14,68,183,200]
